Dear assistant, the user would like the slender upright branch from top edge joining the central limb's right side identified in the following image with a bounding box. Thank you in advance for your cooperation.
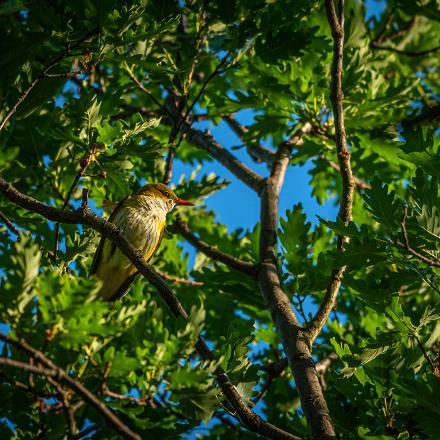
[307,0,355,341]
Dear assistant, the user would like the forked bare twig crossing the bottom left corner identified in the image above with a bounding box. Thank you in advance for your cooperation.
[0,333,141,440]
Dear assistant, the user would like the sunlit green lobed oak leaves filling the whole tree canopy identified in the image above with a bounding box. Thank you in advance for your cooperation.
[0,0,440,439]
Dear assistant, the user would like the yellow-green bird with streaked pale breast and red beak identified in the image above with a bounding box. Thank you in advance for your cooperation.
[90,183,192,301]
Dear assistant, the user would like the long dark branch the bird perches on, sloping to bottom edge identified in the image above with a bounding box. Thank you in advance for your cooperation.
[0,176,298,440]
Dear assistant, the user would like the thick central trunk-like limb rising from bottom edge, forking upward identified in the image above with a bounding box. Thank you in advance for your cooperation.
[258,119,335,439]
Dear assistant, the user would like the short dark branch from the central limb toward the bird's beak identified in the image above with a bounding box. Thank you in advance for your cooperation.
[173,216,257,276]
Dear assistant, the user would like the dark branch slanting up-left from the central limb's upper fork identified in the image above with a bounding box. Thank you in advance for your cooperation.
[182,124,263,193]
